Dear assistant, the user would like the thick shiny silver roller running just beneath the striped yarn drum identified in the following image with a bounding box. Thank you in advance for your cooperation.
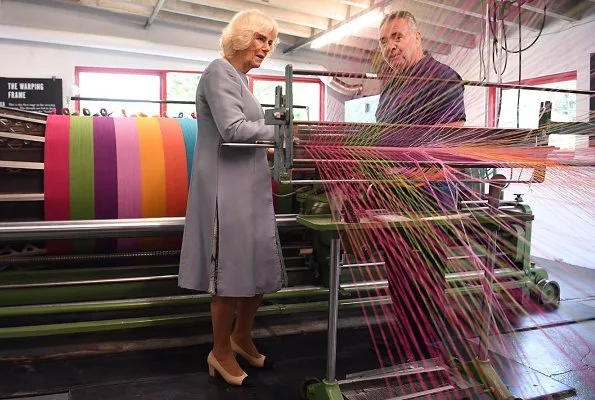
[0,217,299,242]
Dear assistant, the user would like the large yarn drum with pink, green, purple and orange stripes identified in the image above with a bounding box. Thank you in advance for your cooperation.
[44,115,197,251]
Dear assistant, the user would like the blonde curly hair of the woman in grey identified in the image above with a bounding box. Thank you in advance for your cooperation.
[219,10,279,57]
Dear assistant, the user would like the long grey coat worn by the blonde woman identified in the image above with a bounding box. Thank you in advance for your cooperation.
[178,59,287,297]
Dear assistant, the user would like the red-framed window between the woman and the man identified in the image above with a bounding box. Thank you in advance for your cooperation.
[251,77,324,121]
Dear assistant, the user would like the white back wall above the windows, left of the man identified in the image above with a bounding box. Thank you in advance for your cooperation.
[0,0,368,114]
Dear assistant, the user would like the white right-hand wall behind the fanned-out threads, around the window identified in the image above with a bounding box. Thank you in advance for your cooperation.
[436,16,595,269]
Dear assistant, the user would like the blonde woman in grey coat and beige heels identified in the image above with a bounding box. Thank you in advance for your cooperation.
[179,10,287,386]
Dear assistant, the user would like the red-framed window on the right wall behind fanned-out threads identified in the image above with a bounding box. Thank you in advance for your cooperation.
[492,72,577,129]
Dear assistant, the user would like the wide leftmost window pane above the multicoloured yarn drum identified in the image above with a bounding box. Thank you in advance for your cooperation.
[75,67,161,116]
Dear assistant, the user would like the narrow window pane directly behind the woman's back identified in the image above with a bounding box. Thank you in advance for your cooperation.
[165,72,201,117]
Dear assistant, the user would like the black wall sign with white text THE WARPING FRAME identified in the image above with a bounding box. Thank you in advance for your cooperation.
[0,78,62,114]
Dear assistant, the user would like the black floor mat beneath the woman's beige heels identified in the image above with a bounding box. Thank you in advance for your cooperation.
[0,328,378,400]
